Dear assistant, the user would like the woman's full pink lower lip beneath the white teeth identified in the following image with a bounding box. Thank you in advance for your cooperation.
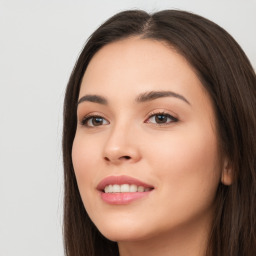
[101,190,152,204]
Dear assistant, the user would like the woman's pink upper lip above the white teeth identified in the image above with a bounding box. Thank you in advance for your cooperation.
[97,175,154,191]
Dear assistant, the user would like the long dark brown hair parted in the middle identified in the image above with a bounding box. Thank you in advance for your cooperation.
[63,10,256,256]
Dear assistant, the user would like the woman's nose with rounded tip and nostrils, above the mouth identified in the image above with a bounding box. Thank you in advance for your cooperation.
[103,127,141,165]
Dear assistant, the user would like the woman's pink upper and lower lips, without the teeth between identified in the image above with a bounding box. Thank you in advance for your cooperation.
[97,175,154,205]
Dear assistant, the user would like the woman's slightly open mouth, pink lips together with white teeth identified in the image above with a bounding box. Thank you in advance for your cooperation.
[97,175,154,204]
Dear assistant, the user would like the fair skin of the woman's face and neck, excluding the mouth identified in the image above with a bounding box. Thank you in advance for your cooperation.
[72,37,231,256]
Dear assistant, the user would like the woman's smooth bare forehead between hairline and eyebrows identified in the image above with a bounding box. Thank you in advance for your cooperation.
[80,37,208,102]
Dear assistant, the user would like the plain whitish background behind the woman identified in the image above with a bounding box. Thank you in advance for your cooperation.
[0,0,256,256]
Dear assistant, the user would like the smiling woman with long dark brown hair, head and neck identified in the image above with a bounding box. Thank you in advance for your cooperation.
[63,10,256,256]
